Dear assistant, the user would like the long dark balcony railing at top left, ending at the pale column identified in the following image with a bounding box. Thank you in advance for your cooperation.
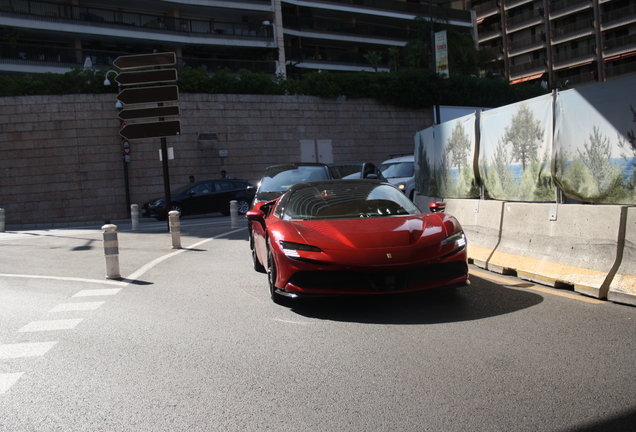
[0,0,273,39]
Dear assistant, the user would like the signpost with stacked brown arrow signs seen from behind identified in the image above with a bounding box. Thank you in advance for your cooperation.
[113,52,181,229]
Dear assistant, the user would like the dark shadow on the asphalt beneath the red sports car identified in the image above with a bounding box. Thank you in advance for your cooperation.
[292,277,543,324]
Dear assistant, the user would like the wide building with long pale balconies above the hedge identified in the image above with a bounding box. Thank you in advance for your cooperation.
[0,0,473,74]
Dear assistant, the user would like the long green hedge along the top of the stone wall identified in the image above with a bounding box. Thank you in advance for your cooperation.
[0,68,548,108]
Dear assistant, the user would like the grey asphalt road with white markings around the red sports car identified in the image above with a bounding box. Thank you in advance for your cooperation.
[0,217,636,432]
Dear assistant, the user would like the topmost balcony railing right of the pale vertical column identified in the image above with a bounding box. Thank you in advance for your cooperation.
[308,0,470,22]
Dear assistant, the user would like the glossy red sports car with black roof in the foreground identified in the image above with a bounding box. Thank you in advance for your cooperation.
[246,180,468,303]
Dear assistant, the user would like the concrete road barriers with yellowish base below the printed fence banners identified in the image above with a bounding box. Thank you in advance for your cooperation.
[444,199,636,305]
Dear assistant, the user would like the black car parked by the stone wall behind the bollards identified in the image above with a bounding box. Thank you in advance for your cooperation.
[141,180,254,220]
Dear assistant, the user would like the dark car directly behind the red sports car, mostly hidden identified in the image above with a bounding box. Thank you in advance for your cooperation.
[254,162,334,208]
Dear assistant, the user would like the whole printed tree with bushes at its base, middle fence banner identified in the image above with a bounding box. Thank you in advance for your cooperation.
[480,103,554,201]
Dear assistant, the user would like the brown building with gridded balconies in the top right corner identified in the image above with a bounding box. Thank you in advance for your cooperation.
[472,0,636,88]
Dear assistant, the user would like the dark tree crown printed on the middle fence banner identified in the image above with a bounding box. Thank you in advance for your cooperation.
[499,103,543,171]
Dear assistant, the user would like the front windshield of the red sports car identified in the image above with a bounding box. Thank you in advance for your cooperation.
[283,182,421,220]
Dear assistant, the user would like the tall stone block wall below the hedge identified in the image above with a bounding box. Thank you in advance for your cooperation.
[0,94,433,228]
